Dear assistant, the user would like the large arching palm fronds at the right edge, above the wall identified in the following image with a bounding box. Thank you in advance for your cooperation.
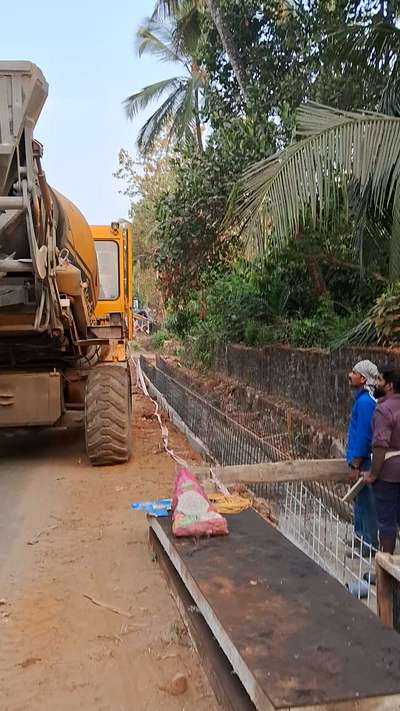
[238,8,400,272]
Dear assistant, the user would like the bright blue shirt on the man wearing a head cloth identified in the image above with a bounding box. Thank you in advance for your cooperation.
[346,390,376,470]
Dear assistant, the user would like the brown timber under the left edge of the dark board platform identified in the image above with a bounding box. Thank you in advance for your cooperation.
[149,528,255,711]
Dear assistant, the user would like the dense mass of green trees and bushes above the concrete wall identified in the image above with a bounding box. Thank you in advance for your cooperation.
[126,0,400,356]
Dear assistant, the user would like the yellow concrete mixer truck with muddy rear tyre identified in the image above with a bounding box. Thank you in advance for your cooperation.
[0,61,132,465]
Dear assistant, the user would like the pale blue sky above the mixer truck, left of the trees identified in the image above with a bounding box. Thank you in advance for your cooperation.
[0,0,176,224]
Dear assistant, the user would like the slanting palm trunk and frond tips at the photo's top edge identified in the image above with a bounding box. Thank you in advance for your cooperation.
[153,0,249,100]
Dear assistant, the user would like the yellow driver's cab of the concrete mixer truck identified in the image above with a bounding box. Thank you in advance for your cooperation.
[91,223,133,340]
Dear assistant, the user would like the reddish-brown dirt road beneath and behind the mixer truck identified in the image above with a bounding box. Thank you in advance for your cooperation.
[0,394,217,711]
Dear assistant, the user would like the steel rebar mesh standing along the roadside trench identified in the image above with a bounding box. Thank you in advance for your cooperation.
[141,358,376,610]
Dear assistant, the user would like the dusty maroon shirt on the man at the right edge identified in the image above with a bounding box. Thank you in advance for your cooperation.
[372,394,400,481]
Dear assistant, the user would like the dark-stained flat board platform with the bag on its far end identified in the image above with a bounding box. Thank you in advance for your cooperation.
[150,510,400,711]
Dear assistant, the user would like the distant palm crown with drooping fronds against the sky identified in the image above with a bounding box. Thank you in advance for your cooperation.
[124,17,206,155]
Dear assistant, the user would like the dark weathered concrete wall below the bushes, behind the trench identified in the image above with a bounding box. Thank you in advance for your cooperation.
[213,345,400,433]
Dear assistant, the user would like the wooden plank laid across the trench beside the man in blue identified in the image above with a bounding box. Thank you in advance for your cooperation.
[193,459,349,484]
